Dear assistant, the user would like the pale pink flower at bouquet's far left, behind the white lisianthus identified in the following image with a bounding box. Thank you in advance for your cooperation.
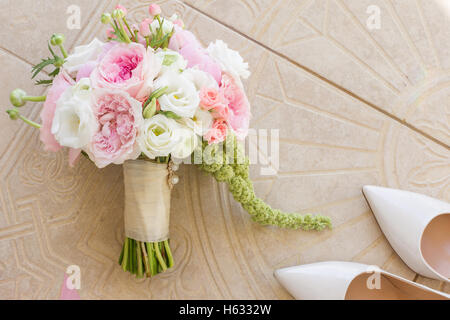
[40,71,75,152]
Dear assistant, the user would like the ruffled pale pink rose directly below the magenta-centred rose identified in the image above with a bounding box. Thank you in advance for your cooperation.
[88,89,143,168]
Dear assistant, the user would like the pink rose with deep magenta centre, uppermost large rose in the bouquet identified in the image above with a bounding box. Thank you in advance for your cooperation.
[91,43,161,101]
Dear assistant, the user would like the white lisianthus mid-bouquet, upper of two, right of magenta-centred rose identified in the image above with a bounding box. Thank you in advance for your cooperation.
[155,71,200,118]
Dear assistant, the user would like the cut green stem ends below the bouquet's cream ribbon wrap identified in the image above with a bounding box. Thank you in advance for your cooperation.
[119,238,173,278]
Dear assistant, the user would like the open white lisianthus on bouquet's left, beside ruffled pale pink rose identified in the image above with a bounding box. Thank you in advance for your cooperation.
[52,78,99,149]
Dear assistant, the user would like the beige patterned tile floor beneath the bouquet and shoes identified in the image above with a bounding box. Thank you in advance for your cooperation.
[0,0,450,299]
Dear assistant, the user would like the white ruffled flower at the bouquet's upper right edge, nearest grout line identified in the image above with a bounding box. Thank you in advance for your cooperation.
[207,40,250,79]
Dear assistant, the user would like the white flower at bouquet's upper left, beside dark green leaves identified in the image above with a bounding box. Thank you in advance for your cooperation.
[64,38,105,76]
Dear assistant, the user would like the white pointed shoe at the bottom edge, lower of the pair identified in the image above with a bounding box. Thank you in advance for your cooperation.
[274,261,450,300]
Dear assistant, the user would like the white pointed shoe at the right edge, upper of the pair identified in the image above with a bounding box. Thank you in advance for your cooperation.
[363,186,450,281]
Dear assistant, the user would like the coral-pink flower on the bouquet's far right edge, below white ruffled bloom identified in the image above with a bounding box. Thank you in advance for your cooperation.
[220,73,251,140]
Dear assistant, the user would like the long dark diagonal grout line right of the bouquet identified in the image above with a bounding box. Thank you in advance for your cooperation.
[180,0,450,150]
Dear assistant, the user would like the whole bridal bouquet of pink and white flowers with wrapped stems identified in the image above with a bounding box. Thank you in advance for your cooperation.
[7,4,331,277]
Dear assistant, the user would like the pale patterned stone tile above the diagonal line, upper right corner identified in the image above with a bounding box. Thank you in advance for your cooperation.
[185,0,450,146]
